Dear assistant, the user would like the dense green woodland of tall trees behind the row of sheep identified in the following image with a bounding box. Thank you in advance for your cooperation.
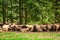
[0,0,60,24]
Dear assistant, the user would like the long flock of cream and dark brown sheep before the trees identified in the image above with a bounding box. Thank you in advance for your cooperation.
[0,23,60,32]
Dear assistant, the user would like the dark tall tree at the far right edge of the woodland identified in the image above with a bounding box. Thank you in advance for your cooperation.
[54,0,60,23]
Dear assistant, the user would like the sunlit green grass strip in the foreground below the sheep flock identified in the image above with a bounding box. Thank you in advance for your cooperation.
[0,32,60,40]
